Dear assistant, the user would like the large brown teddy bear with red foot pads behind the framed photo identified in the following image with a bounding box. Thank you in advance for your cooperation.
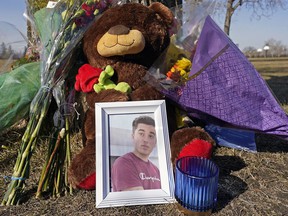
[69,2,214,189]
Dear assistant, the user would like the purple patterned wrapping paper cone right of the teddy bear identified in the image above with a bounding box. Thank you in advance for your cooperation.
[166,16,288,138]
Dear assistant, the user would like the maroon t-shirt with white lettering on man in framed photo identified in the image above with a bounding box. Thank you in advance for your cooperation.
[111,152,161,192]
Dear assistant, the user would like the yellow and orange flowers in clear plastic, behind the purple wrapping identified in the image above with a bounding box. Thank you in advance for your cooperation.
[145,0,215,101]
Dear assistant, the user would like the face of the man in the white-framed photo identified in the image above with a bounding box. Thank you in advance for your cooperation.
[132,123,157,156]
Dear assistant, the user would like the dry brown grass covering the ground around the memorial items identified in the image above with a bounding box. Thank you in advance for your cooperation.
[0,58,288,216]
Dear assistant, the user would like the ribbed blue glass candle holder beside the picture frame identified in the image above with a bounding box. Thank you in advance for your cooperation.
[175,157,219,212]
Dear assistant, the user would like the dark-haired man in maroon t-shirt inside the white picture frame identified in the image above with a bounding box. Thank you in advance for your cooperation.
[111,115,161,192]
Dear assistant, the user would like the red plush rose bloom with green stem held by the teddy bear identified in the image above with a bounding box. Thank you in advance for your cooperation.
[74,64,103,93]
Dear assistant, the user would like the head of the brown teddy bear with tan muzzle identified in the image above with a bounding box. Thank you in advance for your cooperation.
[84,3,173,67]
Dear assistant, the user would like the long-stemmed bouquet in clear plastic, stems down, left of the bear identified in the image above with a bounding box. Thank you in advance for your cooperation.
[2,0,113,205]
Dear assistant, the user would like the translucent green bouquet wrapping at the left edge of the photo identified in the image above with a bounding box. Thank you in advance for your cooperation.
[0,62,40,131]
